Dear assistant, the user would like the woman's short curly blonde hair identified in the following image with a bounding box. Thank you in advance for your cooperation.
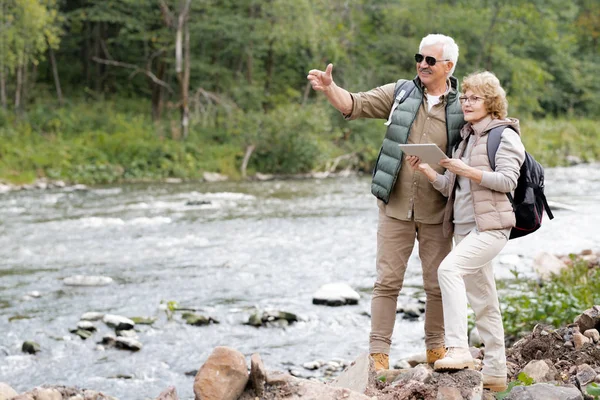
[462,71,508,119]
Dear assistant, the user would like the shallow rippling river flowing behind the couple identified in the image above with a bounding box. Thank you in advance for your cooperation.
[0,164,600,399]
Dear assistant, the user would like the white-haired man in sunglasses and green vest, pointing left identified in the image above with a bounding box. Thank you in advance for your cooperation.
[308,34,465,370]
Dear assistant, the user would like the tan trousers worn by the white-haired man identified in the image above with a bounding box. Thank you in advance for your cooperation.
[369,207,452,354]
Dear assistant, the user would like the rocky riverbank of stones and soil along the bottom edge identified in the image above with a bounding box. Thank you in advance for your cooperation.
[0,305,600,400]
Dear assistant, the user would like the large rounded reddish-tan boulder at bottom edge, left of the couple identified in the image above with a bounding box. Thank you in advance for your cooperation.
[194,346,249,400]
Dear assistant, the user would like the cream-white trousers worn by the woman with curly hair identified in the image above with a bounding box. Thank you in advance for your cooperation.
[438,229,508,377]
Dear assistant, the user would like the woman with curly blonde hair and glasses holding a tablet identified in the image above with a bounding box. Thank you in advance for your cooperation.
[408,72,525,391]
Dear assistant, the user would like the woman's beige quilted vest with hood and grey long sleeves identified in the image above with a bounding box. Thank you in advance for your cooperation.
[433,116,525,236]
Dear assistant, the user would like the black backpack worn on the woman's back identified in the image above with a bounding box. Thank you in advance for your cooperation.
[487,126,554,239]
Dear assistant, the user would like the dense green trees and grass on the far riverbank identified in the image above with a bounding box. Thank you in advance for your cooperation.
[0,0,600,183]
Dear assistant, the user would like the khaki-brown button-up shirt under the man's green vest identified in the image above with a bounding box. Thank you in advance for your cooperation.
[345,83,448,224]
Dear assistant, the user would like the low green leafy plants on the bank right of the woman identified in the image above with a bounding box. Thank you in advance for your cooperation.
[499,255,600,342]
